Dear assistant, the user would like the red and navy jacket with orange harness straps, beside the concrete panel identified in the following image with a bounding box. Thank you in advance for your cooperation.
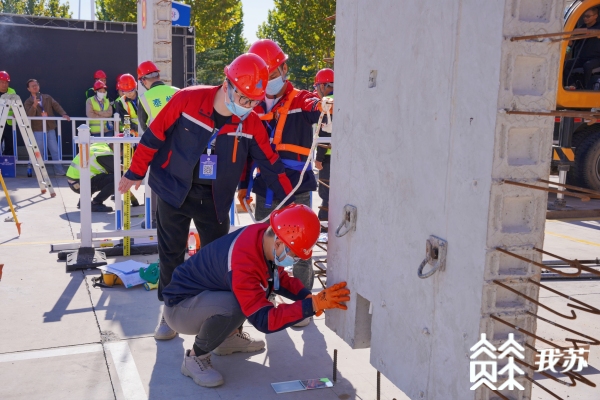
[240,82,321,207]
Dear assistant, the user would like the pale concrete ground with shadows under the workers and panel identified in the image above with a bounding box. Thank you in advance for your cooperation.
[0,167,600,400]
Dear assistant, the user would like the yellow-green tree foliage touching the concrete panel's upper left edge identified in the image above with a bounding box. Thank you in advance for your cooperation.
[256,0,335,89]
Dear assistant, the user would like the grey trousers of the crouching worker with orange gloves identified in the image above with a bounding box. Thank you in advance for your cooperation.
[163,290,246,353]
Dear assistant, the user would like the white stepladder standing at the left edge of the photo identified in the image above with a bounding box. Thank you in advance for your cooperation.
[0,94,56,197]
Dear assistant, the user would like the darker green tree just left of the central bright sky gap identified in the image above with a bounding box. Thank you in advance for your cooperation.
[196,3,248,85]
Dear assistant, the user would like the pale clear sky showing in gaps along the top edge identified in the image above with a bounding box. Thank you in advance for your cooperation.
[60,0,274,43]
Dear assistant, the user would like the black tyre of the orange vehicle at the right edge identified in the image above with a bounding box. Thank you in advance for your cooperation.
[571,132,600,191]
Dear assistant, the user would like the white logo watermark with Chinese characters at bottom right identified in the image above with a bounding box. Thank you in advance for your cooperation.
[470,333,589,390]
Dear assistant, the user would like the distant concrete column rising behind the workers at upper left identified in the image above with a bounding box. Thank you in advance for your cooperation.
[138,0,172,85]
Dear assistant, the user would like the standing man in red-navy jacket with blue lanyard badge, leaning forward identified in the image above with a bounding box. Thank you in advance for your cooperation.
[119,54,293,339]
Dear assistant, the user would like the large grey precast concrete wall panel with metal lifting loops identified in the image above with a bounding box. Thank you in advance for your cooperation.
[326,0,563,400]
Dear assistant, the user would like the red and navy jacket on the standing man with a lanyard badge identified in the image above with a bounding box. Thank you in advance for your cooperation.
[125,86,292,221]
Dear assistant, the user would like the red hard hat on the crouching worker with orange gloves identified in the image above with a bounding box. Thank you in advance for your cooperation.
[271,204,321,260]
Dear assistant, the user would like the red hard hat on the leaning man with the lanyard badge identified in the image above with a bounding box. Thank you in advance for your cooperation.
[225,53,269,100]
